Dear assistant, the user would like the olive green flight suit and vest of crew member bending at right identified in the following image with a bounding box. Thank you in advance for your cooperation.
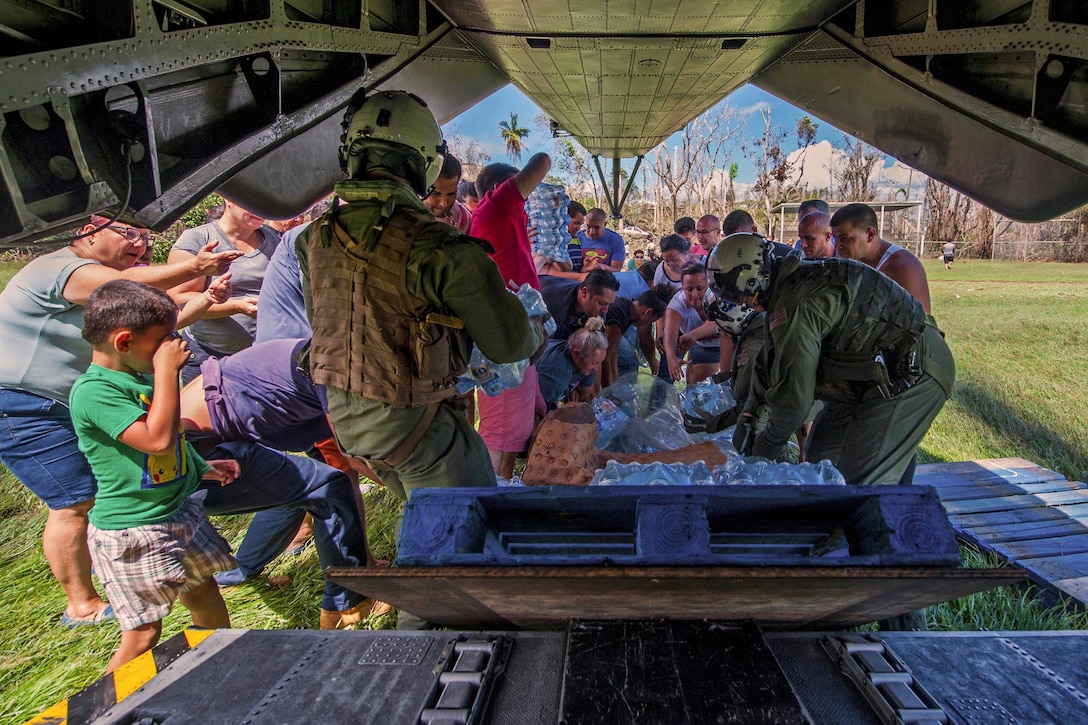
[737,255,955,483]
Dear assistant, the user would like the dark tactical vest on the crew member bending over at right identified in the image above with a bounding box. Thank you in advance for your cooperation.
[768,260,926,401]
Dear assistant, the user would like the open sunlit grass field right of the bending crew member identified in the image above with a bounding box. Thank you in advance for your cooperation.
[922,260,1088,480]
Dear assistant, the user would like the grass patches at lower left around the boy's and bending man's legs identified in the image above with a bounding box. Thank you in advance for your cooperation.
[0,468,400,723]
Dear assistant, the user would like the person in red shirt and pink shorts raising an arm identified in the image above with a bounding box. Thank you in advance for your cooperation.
[469,153,552,478]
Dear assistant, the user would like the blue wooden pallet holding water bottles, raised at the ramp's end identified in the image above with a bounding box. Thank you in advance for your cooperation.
[396,486,960,567]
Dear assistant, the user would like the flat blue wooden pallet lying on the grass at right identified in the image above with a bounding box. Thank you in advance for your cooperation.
[914,458,1088,606]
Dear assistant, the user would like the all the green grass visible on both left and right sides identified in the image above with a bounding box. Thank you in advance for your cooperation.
[0,260,1088,722]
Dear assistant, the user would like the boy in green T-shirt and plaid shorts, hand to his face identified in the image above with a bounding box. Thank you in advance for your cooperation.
[71,280,240,673]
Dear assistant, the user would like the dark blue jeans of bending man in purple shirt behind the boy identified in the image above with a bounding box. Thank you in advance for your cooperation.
[194,441,367,612]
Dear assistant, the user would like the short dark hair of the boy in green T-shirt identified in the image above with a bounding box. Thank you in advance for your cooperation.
[83,280,177,345]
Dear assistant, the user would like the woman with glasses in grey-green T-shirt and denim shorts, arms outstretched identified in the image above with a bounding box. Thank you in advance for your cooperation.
[0,216,238,627]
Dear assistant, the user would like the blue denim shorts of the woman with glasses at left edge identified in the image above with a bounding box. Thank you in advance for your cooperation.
[0,389,98,509]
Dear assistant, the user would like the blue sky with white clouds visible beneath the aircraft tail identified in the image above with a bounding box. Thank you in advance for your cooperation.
[444,85,917,191]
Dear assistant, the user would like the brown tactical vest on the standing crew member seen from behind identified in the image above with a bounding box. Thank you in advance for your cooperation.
[307,203,471,408]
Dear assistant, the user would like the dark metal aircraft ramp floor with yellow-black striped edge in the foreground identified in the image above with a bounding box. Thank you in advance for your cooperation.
[30,620,1088,725]
